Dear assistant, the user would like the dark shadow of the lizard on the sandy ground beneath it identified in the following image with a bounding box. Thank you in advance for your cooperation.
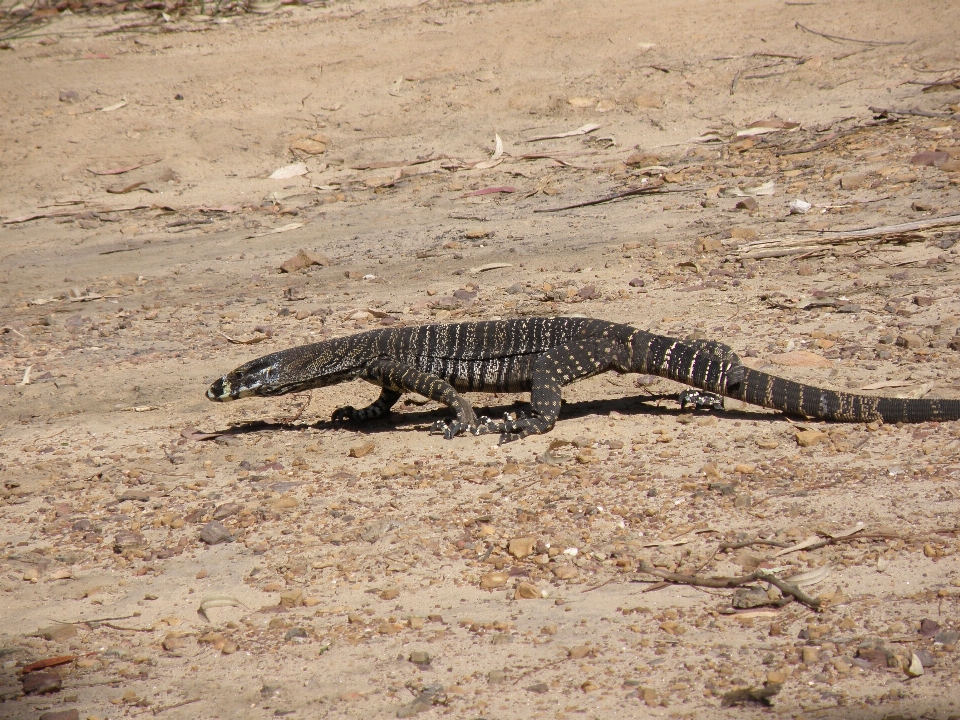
[209,394,796,439]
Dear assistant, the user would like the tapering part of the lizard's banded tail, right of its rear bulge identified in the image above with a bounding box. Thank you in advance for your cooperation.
[723,366,960,423]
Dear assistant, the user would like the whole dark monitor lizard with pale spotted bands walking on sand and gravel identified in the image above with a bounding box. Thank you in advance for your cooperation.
[207,317,960,441]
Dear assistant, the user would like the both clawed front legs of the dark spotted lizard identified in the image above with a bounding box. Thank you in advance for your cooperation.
[334,359,477,439]
